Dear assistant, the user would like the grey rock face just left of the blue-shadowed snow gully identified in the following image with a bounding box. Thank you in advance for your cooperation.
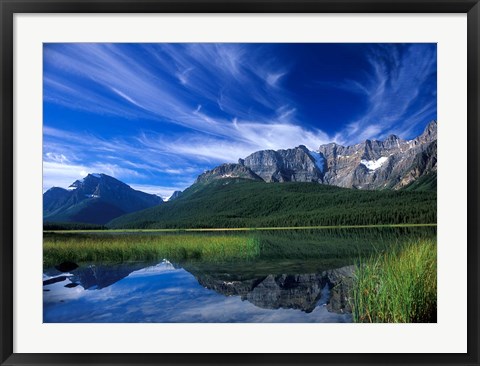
[239,145,323,183]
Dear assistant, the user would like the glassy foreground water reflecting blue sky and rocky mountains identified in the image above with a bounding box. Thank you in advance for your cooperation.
[43,260,351,323]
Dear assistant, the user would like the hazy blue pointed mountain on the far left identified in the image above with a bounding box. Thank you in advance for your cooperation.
[43,174,163,224]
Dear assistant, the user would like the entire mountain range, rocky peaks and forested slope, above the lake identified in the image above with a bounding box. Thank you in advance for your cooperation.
[43,121,437,228]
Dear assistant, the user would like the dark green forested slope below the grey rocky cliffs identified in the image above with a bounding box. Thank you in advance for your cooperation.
[107,178,436,228]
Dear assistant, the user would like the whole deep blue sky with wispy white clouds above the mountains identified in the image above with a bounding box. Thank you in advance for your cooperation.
[43,43,437,197]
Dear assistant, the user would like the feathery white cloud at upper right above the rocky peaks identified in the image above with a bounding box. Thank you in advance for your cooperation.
[334,44,437,144]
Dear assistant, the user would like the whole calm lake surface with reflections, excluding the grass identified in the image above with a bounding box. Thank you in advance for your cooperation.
[43,228,435,323]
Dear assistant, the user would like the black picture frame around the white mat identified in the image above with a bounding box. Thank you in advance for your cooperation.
[0,0,480,365]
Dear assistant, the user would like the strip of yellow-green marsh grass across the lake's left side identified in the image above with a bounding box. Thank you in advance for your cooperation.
[43,234,260,267]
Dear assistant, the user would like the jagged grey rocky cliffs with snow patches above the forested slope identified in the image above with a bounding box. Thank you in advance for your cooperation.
[197,121,437,190]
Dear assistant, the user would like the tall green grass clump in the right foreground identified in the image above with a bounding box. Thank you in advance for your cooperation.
[352,239,437,323]
